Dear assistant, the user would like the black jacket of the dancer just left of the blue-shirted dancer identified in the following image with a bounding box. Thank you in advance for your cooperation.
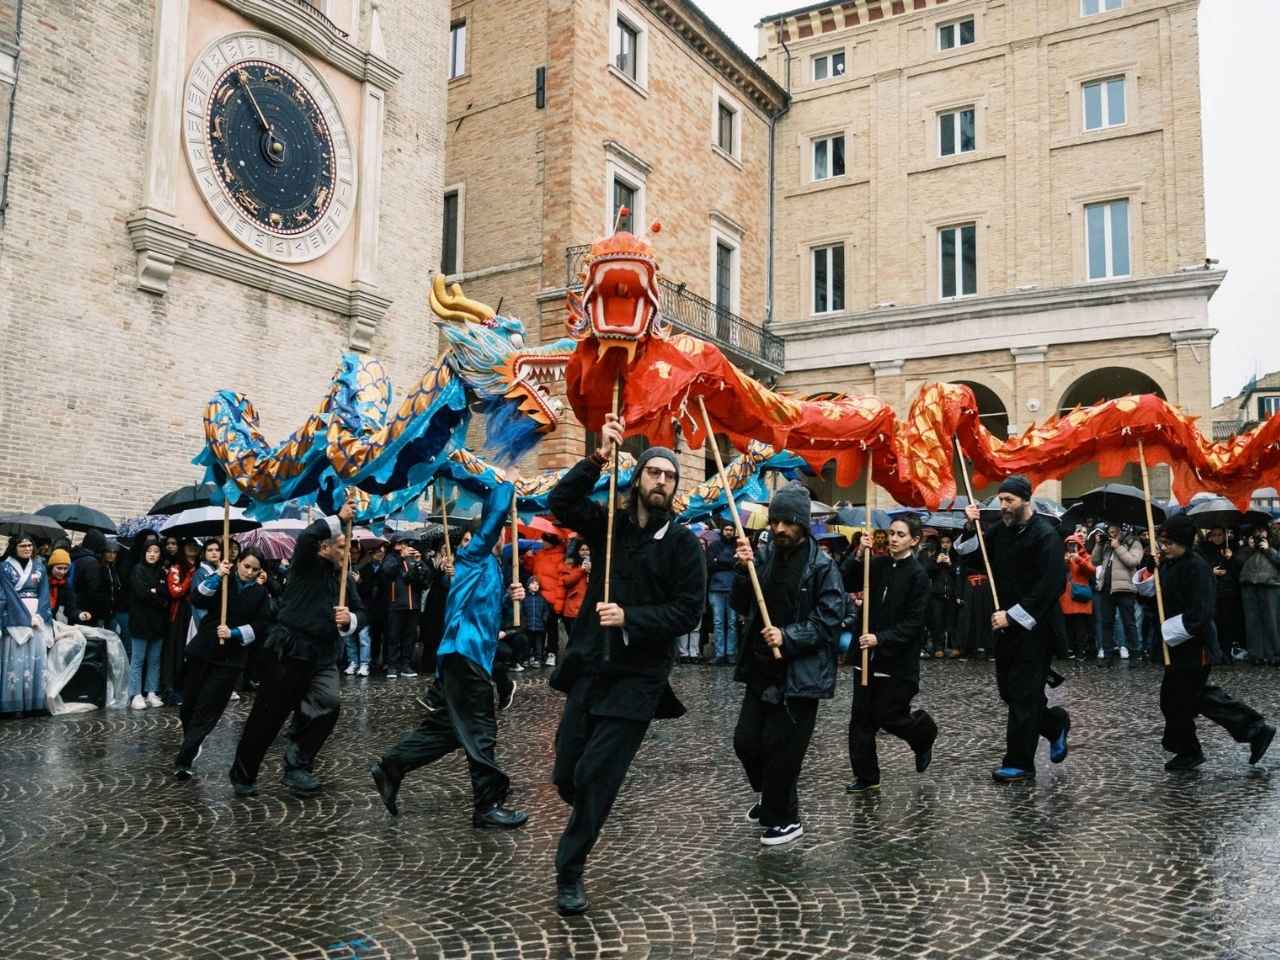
[269,517,364,666]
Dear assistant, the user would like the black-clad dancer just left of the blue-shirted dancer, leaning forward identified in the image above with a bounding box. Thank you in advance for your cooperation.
[229,503,362,796]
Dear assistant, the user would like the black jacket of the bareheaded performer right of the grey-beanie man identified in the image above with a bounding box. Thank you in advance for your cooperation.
[851,557,929,687]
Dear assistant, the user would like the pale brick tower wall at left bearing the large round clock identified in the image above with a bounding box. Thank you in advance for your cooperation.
[0,0,448,517]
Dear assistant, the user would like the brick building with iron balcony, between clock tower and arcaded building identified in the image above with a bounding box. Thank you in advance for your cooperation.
[442,0,785,480]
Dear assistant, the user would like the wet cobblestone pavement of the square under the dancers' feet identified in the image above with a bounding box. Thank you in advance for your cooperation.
[0,662,1280,960]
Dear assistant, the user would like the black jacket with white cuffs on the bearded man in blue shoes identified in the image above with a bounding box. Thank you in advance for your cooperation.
[957,515,1066,643]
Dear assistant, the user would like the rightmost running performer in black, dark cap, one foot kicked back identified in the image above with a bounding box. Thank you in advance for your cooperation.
[1138,513,1276,771]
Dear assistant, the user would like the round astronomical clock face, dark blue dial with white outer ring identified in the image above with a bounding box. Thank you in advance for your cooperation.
[183,33,356,262]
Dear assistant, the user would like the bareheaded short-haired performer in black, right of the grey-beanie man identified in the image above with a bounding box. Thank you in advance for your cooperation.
[847,516,938,794]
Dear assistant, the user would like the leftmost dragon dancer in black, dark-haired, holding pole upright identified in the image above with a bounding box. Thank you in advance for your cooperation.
[174,547,271,780]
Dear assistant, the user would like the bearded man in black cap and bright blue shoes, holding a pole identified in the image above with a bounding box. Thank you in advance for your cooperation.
[956,474,1071,783]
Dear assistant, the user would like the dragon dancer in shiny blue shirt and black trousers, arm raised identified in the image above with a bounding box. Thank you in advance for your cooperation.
[369,471,529,829]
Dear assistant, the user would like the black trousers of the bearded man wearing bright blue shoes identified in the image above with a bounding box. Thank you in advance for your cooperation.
[996,625,1069,772]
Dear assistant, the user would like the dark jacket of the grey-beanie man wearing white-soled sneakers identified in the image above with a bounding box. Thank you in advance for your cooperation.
[731,538,845,700]
